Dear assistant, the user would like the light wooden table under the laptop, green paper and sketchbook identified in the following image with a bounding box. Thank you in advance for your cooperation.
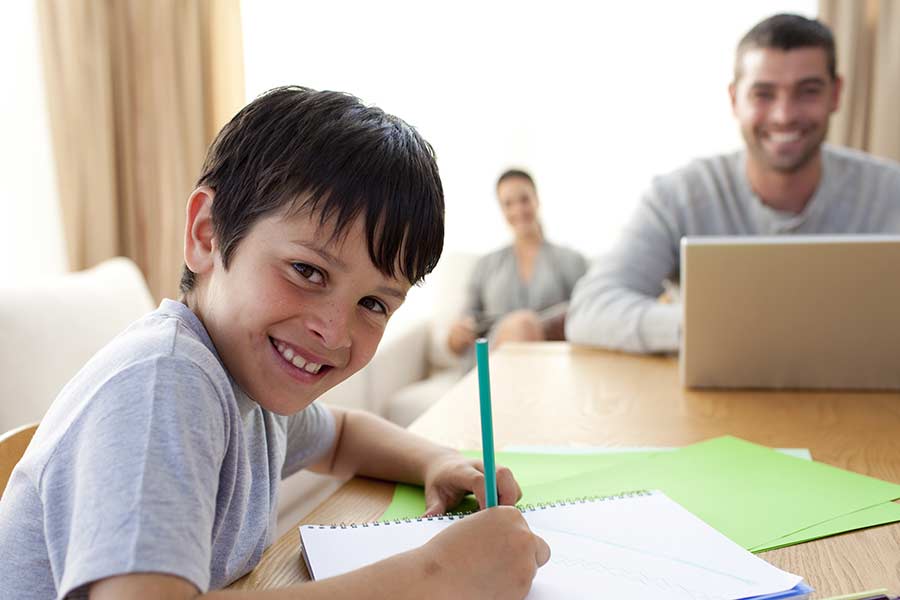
[233,343,900,598]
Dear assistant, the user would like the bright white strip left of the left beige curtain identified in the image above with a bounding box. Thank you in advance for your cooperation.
[0,1,67,287]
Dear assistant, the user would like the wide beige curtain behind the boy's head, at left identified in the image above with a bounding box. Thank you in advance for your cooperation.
[38,0,244,299]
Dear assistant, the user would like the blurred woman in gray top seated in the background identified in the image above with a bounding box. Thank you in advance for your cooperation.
[447,169,587,366]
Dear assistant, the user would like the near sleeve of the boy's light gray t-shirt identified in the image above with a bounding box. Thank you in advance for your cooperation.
[39,357,227,597]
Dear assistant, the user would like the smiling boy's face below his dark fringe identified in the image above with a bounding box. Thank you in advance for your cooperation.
[189,199,410,415]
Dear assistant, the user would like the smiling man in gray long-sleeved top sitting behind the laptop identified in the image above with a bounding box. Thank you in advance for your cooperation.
[566,14,900,352]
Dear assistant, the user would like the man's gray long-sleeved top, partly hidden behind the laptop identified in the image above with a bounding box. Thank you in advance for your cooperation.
[566,145,900,352]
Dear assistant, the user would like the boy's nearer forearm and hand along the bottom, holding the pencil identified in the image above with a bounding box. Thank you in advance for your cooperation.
[90,507,550,600]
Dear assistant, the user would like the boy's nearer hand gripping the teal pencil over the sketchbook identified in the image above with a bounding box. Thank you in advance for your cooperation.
[415,506,550,600]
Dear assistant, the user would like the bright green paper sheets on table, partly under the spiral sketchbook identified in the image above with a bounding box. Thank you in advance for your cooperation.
[382,437,900,552]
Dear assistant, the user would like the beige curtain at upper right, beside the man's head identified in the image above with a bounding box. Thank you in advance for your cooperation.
[819,0,900,161]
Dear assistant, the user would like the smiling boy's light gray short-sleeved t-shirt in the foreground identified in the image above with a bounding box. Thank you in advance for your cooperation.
[0,300,335,600]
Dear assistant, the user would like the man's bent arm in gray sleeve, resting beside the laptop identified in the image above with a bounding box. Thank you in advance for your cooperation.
[565,192,681,352]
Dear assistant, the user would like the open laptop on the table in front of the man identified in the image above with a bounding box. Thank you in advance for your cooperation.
[680,235,900,390]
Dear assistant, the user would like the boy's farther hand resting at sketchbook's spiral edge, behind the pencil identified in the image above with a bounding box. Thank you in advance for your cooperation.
[425,452,522,516]
